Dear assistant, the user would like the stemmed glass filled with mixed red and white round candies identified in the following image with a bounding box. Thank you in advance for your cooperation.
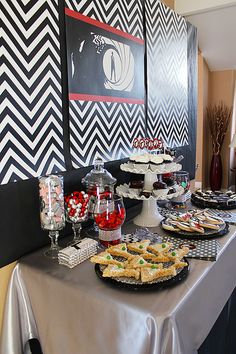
[64,191,89,246]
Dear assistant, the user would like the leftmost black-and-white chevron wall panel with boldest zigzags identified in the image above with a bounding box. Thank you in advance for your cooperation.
[0,0,65,184]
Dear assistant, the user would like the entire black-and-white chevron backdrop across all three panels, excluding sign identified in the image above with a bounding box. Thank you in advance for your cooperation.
[0,0,192,184]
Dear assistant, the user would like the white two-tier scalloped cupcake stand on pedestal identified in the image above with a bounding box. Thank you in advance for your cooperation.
[116,163,184,227]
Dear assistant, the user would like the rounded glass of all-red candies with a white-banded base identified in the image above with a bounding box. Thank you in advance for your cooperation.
[94,193,126,247]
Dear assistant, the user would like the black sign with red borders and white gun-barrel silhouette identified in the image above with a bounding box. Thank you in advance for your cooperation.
[65,9,144,104]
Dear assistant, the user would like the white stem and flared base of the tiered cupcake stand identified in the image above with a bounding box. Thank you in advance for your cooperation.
[134,172,163,227]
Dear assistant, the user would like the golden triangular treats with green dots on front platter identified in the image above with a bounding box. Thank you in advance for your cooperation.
[90,240,189,289]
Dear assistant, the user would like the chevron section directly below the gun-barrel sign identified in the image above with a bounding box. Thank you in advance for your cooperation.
[70,101,145,167]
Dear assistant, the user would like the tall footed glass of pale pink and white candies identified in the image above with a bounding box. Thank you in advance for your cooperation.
[39,175,65,259]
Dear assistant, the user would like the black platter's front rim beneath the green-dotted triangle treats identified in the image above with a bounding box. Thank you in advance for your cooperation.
[95,258,189,291]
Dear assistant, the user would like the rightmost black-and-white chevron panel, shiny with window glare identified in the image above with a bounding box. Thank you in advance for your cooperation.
[145,0,188,147]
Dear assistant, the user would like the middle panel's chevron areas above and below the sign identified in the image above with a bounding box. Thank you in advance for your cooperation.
[66,0,146,168]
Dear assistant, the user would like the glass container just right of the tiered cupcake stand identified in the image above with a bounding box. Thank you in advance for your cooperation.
[171,171,190,208]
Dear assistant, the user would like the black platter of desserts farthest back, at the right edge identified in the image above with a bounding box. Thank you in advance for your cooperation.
[191,189,236,210]
